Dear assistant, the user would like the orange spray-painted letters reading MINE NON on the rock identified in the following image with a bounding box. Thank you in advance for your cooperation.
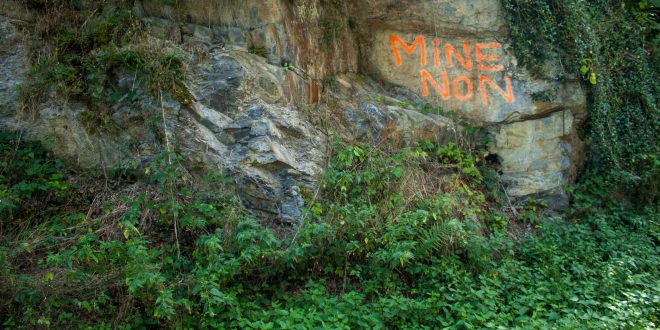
[390,34,515,105]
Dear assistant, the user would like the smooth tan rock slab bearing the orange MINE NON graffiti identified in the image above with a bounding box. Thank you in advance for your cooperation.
[342,0,586,208]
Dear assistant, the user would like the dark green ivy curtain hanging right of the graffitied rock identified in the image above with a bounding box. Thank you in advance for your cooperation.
[502,0,660,206]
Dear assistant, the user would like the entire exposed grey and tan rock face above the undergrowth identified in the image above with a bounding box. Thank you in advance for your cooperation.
[0,0,585,222]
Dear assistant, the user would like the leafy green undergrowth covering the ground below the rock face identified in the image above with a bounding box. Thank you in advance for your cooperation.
[0,134,660,329]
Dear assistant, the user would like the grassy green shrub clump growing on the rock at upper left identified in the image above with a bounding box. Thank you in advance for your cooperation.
[20,0,190,110]
